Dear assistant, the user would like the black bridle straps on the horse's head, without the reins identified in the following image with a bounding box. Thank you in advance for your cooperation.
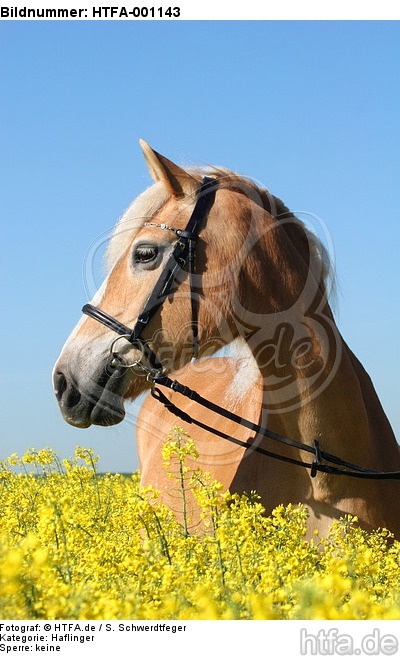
[82,177,218,376]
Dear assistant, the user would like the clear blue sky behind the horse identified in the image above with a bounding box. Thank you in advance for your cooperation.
[0,21,400,471]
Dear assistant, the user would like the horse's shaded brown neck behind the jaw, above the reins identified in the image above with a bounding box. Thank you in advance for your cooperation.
[219,199,400,469]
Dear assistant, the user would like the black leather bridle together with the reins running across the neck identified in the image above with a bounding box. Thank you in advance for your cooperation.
[82,177,400,480]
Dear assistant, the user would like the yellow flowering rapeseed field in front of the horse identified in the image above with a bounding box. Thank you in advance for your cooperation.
[0,428,400,619]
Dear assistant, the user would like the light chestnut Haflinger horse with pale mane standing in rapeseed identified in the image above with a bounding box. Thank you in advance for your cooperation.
[53,141,400,537]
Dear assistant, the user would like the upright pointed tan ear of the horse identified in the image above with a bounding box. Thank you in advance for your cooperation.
[139,139,198,197]
